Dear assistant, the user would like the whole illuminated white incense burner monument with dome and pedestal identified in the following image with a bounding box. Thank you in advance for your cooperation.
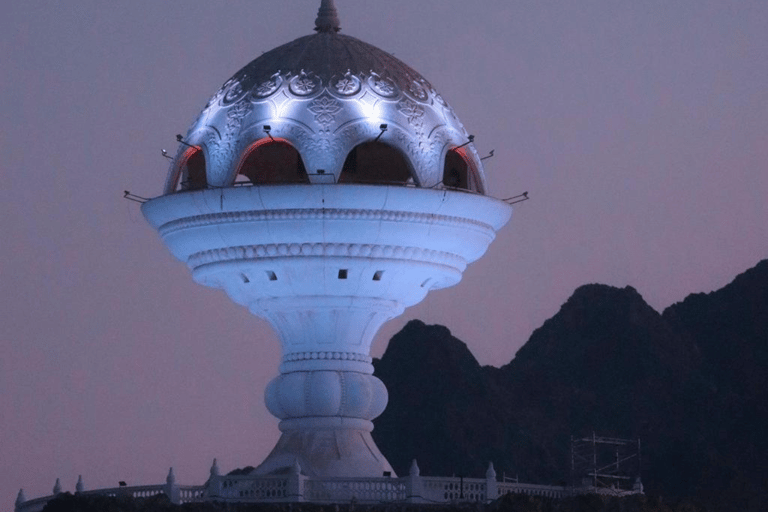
[142,0,511,477]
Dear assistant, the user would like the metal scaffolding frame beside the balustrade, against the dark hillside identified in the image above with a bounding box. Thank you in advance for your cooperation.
[571,432,642,491]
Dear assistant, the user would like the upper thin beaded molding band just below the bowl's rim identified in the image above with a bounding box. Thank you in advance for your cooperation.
[158,208,494,237]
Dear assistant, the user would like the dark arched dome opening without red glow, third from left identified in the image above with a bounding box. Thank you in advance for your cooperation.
[339,141,413,184]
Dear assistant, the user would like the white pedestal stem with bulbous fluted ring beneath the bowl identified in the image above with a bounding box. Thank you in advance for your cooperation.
[251,296,402,476]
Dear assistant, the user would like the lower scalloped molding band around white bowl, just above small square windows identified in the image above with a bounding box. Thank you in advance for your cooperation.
[187,243,467,269]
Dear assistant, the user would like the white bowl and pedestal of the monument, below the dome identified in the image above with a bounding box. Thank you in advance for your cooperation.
[142,184,512,478]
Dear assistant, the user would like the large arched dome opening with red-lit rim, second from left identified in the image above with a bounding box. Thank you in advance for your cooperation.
[235,138,309,185]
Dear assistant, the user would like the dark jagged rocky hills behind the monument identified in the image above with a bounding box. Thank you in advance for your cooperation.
[373,261,768,510]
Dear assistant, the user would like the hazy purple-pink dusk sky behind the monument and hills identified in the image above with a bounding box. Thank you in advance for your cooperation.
[0,0,768,510]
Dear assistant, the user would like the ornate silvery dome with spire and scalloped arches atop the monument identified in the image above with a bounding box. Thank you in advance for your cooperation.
[166,0,485,193]
